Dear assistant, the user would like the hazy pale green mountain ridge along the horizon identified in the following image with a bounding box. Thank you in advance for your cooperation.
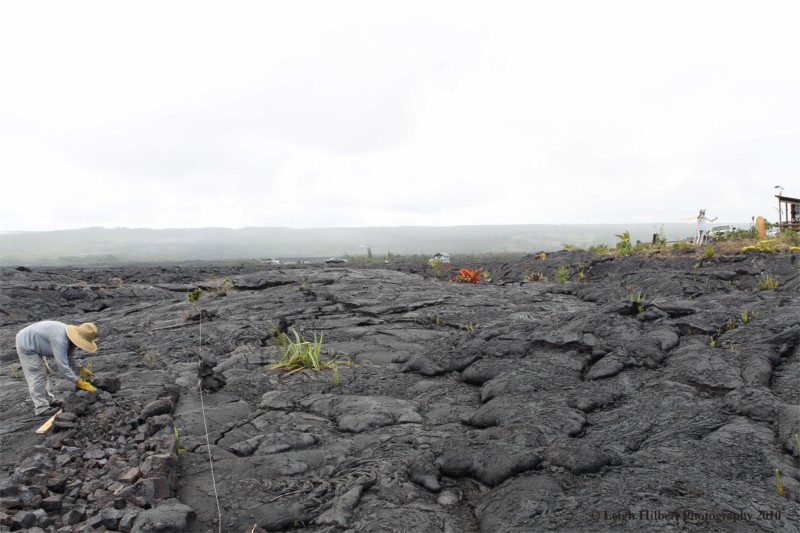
[0,223,720,266]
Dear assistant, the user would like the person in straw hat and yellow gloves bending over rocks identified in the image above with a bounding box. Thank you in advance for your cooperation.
[17,320,97,416]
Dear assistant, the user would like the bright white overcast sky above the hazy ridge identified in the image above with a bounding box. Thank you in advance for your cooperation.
[0,0,800,231]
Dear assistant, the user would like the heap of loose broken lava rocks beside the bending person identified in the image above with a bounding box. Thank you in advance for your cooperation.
[0,379,194,533]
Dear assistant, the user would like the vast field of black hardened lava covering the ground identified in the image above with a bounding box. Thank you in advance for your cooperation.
[0,251,800,533]
